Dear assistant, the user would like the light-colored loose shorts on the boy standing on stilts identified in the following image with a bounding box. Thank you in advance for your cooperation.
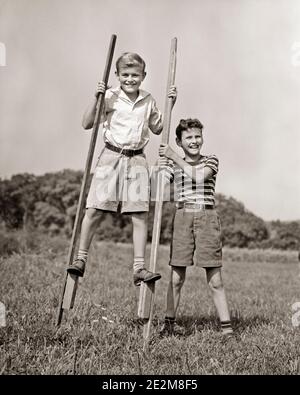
[86,148,150,213]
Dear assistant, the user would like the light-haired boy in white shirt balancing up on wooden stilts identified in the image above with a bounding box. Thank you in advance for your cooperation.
[67,52,177,285]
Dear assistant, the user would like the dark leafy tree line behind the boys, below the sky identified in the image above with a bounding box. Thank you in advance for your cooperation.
[0,170,300,250]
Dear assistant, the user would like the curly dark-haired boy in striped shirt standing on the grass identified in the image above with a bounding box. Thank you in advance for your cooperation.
[158,119,233,335]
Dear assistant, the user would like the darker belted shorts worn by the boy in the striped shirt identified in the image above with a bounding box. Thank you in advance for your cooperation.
[170,208,222,267]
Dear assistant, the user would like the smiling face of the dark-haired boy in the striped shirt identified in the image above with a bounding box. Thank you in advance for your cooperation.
[176,128,203,160]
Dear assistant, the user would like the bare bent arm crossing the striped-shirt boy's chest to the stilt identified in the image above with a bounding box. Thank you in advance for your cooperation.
[159,144,215,182]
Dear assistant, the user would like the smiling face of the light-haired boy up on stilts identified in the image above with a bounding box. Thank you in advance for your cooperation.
[116,64,146,100]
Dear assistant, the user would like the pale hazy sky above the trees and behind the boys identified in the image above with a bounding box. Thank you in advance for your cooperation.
[0,0,300,220]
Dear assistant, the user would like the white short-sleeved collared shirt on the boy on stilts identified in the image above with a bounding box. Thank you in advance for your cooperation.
[102,87,162,149]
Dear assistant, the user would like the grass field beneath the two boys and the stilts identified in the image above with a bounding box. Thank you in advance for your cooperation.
[0,240,300,375]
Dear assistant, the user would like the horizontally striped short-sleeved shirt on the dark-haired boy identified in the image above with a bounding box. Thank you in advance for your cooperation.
[166,155,219,206]
